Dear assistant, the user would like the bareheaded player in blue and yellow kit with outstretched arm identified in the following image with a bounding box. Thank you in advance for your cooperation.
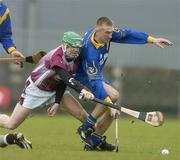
[76,17,172,151]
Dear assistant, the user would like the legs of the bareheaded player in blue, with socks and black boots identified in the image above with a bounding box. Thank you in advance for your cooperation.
[78,83,119,151]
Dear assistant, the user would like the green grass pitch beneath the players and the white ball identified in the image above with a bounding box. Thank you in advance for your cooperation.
[0,115,180,160]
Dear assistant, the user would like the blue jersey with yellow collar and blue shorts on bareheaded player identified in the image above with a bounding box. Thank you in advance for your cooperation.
[76,29,148,99]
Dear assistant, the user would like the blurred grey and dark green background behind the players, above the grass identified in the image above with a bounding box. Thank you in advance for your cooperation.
[0,0,180,117]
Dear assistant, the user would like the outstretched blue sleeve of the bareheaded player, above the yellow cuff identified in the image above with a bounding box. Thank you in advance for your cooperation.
[111,29,149,44]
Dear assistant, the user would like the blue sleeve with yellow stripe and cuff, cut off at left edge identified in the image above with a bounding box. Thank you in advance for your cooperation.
[0,2,15,53]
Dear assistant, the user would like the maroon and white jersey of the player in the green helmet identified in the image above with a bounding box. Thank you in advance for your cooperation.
[31,45,78,91]
